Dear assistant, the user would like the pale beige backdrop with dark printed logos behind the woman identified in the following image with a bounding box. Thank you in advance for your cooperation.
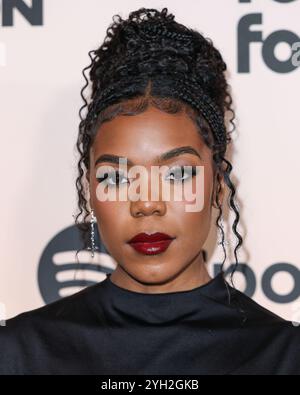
[0,0,300,321]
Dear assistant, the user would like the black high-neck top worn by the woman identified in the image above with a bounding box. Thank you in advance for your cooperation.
[0,273,300,375]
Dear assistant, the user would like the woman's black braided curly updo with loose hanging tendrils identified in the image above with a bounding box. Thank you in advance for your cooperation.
[75,8,243,288]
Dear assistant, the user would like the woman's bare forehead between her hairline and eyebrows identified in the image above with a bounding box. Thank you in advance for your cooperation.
[91,107,210,163]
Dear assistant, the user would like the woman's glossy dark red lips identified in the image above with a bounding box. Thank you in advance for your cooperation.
[128,232,175,255]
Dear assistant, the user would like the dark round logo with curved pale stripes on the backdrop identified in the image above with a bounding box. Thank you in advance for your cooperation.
[38,225,116,304]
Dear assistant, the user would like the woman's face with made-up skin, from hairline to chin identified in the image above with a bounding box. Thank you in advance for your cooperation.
[88,107,221,287]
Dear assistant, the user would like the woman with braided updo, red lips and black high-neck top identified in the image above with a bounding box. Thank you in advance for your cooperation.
[0,8,300,375]
